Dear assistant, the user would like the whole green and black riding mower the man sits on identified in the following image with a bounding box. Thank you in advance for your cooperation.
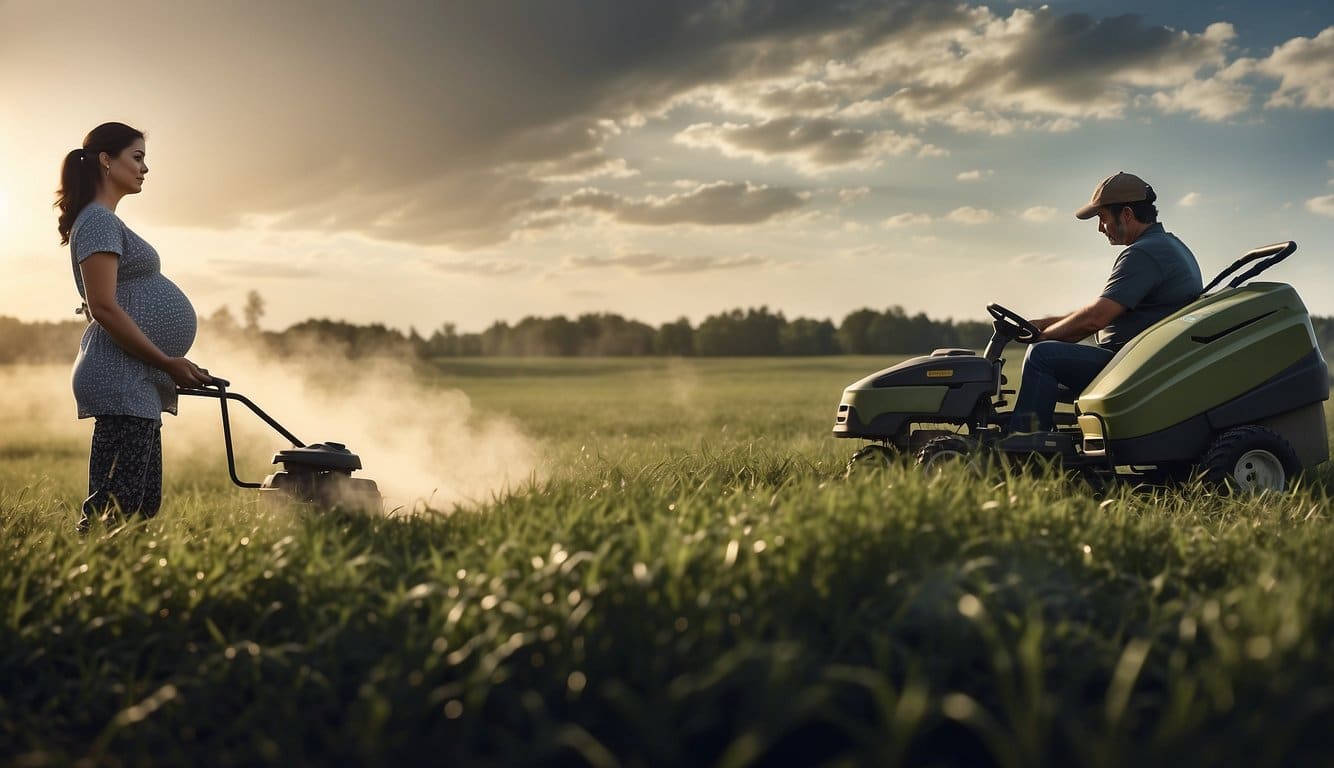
[834,241,1330,489]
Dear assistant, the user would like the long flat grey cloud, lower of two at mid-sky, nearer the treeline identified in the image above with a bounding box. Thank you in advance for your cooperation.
[558,181,807,227]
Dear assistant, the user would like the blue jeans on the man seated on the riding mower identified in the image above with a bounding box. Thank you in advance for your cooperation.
[1010,341,1115,432]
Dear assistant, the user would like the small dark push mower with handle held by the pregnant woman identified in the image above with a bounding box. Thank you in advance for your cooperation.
[177,376,383,512]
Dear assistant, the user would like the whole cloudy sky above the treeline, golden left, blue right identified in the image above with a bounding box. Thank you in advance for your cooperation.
[0,0,1334,335]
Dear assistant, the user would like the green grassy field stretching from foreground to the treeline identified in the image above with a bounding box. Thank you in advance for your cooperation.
[0,357,1334,767]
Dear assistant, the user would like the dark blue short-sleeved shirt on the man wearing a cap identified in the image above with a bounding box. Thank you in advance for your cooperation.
[1098,224,1205,351]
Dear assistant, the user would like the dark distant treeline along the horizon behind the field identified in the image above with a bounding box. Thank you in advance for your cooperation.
[0,303,1334,363]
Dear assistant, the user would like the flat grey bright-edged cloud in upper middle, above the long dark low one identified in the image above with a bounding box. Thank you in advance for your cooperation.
[675,117,922,173]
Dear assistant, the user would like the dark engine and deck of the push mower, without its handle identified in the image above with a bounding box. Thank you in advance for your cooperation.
[259,443,382,511]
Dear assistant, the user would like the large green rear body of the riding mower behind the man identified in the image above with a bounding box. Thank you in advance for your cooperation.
[1075,283,1330,468]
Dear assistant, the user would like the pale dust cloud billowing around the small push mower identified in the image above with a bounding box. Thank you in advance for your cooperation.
[180,343,539,513]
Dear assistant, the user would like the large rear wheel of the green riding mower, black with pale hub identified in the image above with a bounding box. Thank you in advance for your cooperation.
[1201,424,1302,493]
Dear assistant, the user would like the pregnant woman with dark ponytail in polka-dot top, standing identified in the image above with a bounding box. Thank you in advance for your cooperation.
[56,123,212,532]
